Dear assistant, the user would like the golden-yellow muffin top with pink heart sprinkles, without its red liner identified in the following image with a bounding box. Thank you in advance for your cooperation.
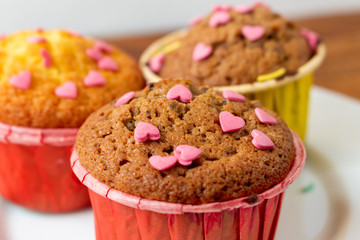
[0,29,144,128]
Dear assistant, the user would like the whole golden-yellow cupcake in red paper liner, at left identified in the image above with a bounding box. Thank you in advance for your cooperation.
[0,29,144,212]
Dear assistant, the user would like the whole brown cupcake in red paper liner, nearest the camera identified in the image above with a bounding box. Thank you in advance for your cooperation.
[71,79,305,239]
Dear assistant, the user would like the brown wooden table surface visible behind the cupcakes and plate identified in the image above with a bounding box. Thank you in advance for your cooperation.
[107,12,360,99]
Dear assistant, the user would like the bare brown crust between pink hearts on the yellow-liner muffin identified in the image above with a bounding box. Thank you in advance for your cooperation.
[159,7,312,86]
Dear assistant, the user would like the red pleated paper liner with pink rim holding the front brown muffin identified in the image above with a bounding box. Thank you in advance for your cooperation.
[71,133,306,240]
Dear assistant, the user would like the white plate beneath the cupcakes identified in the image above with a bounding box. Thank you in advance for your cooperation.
[0,87,360,240]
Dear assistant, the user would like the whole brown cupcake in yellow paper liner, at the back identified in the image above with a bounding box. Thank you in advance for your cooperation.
[140,4,325,138]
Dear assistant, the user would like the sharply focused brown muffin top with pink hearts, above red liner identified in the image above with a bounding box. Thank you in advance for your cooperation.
[75,79,294,204]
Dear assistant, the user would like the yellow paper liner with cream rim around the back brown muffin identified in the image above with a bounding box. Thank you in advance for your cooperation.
[140,30,326,140]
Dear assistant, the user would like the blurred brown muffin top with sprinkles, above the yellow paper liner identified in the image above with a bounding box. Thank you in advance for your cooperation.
[156,4,317,86]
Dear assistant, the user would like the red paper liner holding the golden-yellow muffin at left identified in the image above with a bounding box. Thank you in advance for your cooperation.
[0,123,90,213]
